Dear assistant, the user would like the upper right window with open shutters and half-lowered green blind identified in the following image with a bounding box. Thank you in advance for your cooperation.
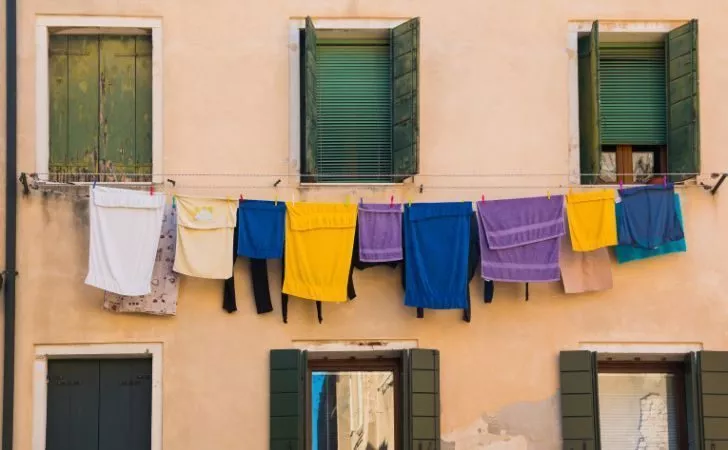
[578,20,700,183]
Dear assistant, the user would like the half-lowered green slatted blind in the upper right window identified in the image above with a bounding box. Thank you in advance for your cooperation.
[599,42,667,145]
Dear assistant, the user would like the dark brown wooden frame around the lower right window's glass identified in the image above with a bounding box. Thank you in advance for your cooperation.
[597,360,688,448]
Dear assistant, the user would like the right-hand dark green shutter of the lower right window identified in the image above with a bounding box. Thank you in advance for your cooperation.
[688,351,728,450]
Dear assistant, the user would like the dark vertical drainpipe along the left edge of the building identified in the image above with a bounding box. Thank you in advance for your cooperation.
[2,0,18,444]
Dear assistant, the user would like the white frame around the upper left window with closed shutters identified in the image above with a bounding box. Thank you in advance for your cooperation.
[35,16,164,183]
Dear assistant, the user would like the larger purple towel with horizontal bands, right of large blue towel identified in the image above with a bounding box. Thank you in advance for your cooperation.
[477,195,565,283]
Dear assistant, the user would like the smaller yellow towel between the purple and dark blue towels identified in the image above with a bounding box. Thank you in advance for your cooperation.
[566,190,617,252]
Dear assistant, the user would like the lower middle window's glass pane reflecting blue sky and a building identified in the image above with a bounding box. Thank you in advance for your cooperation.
[310,371,395,450]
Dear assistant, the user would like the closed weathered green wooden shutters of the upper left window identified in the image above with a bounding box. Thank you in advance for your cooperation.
[48,28,152,182]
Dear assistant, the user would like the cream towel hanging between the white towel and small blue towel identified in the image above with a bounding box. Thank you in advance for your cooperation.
[174,196,238,280]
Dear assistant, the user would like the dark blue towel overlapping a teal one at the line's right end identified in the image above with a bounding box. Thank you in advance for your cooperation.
[617,185,685,249]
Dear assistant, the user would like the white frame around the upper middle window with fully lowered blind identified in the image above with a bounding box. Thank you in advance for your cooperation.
[288,18,410,186]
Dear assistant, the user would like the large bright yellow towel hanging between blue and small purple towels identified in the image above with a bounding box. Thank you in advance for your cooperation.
[283,203,357,302]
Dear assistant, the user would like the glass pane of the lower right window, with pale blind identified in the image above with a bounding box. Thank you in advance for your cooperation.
[599,373,680,450]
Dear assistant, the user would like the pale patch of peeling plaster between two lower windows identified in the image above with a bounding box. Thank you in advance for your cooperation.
[441,395,561,450]
